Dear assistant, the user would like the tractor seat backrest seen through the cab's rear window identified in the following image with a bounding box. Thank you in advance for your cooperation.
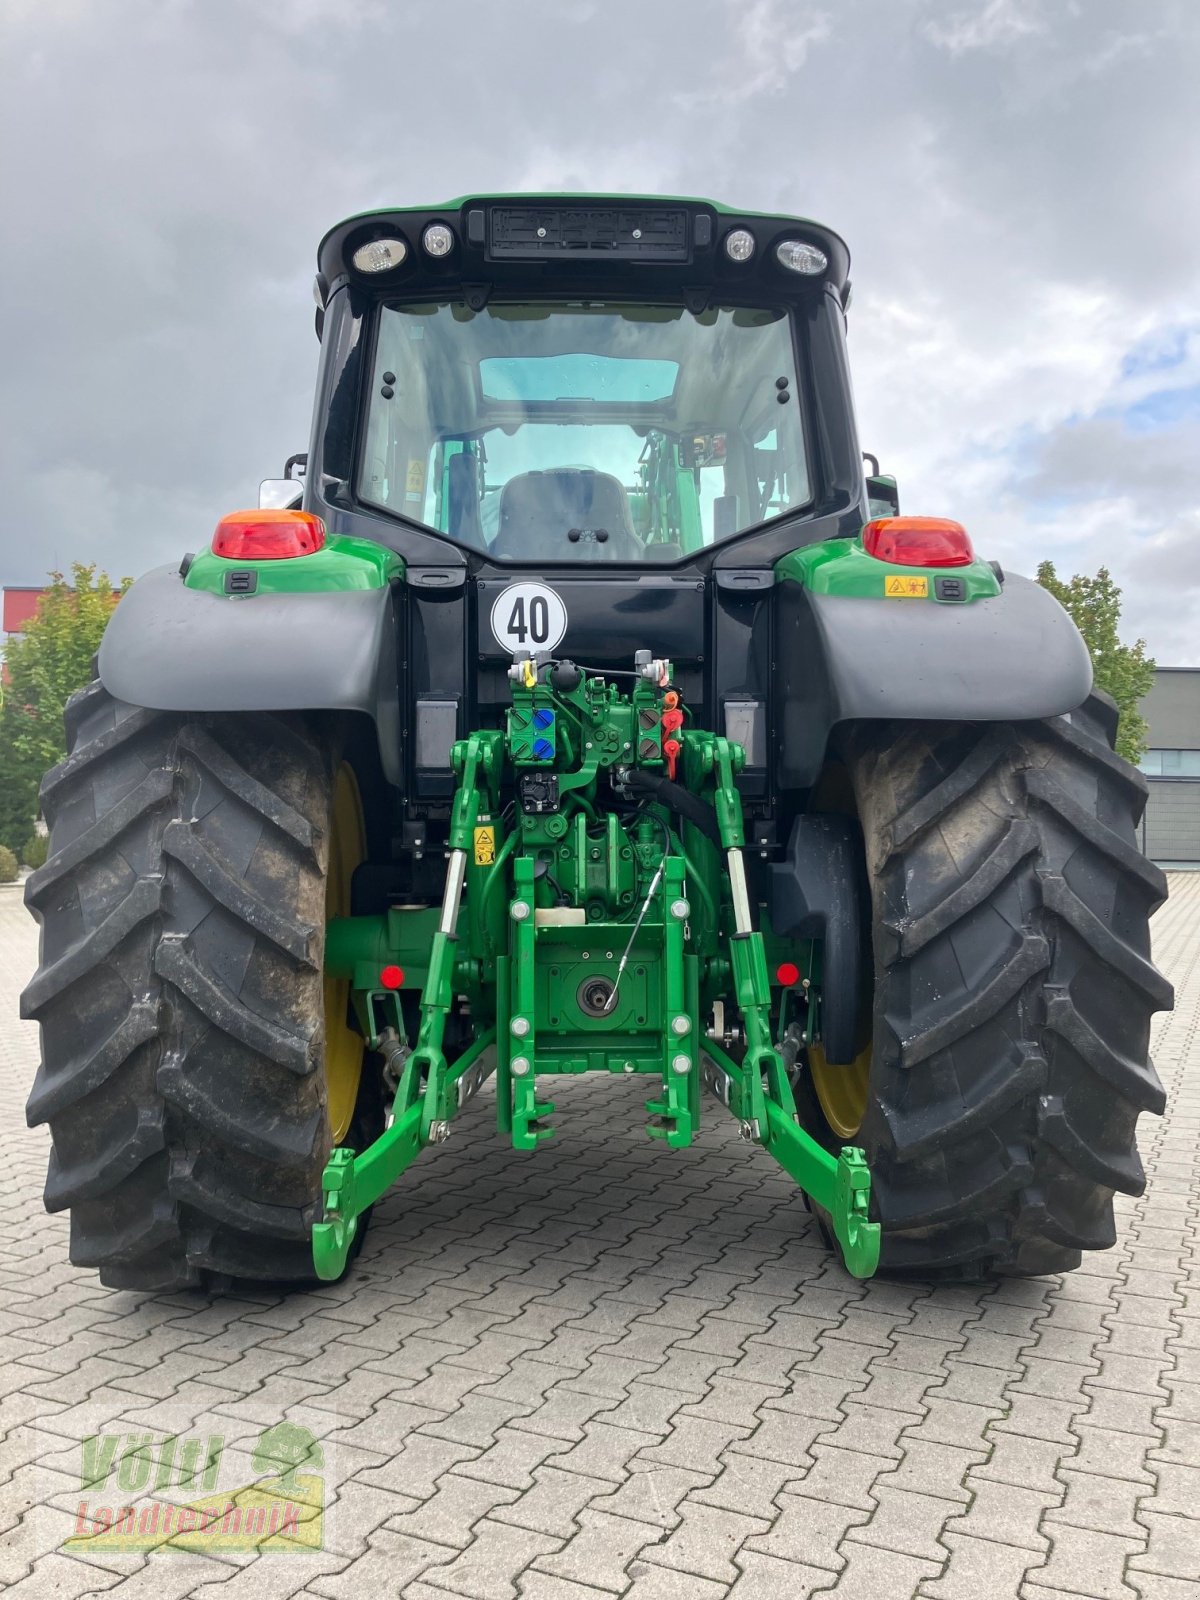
[491,467,645,562]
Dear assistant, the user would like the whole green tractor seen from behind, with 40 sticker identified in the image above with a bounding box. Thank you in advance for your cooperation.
[24,195,1171,1290]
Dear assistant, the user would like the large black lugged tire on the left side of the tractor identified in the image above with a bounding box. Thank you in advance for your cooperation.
[22,683,382,1290]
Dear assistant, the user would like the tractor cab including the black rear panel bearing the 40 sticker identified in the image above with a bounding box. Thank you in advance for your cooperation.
[294,195,867,812]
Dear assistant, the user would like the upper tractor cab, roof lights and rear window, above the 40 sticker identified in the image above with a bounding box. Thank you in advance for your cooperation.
[309,197,866,570]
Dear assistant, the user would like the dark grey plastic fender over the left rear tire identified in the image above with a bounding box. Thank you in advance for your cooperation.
[98,566,402,784]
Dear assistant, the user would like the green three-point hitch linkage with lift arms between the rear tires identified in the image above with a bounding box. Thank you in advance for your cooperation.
[314,646,880,1278]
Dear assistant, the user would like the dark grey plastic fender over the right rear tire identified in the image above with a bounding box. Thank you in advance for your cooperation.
[776,576,1091,789]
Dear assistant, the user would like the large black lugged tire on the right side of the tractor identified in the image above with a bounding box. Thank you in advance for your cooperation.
[826,696,1173,1278]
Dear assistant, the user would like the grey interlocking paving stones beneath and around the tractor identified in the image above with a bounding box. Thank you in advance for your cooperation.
[0,874,1200,1600]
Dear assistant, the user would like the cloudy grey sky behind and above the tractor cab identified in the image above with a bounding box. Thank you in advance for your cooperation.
[0,0,1200,666]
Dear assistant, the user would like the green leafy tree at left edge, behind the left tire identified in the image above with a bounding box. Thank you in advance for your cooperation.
[0,563,131,850]
